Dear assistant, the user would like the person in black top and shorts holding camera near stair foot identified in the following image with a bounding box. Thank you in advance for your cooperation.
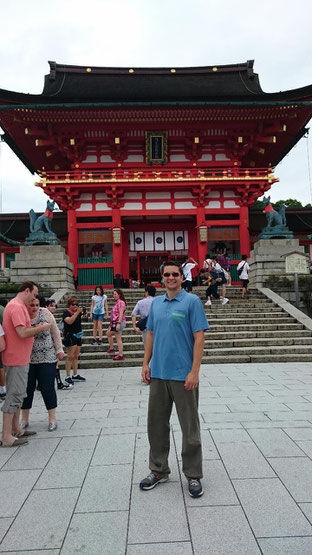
[62,297,87,385]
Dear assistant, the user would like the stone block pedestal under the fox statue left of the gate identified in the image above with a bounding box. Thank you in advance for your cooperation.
[10,245,75,291]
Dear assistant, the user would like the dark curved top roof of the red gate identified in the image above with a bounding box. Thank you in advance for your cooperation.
[0,60,312,104]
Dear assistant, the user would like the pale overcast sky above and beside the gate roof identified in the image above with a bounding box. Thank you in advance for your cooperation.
[0,0,312,212]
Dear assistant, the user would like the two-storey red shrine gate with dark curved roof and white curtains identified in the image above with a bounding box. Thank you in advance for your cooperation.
[0,62,312,287]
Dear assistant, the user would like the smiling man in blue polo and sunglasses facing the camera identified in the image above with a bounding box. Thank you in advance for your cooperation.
[140,261,209,497]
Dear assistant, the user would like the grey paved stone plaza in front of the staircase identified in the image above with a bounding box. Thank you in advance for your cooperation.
[0,363,312,555]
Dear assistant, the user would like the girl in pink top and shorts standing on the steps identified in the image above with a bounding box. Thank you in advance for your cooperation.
[106,289,126,360]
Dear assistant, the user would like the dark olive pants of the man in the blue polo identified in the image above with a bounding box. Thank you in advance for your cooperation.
[147,378,203,478]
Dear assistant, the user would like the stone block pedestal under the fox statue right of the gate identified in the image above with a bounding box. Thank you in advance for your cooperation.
[248,239,304,287]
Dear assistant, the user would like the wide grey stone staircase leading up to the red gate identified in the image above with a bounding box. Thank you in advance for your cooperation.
[55,287,312,369]
